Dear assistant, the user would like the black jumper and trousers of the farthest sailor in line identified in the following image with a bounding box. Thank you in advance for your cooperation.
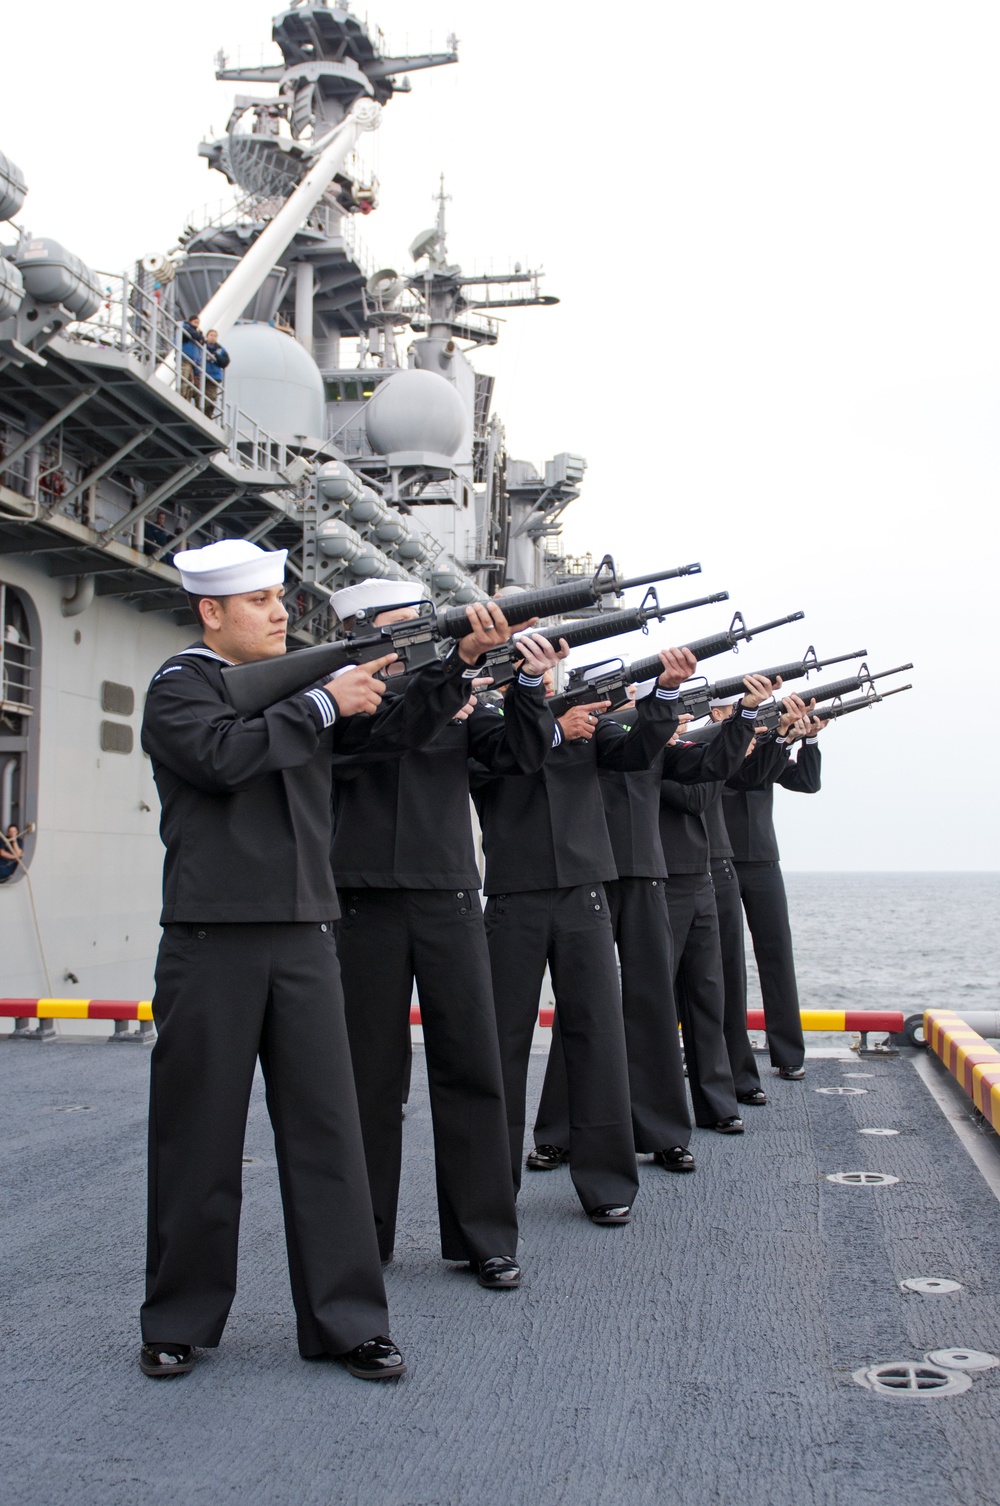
[723,739,819,1068]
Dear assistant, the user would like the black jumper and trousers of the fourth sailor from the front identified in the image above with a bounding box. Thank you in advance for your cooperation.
[535,708,753,1154]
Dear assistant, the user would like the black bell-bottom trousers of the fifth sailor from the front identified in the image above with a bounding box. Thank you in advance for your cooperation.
[667,873,739,1126]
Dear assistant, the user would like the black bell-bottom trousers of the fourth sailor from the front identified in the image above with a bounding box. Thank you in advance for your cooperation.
[535,878,692,1154]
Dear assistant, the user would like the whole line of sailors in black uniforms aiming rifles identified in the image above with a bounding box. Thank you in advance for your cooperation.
[140,541,822,1379]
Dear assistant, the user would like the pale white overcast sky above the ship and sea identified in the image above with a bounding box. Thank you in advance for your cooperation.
[0,0,1000,869]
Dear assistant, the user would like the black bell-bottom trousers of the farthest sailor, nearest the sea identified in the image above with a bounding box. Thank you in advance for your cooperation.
[735,863,806,1068]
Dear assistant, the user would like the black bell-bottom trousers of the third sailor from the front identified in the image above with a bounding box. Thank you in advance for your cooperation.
[486,884,639,1212]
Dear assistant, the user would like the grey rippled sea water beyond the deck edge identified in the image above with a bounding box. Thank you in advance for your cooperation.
[747,872,1000,1015]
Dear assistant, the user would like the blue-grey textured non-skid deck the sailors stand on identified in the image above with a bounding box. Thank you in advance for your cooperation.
[0,1042,1000,1506]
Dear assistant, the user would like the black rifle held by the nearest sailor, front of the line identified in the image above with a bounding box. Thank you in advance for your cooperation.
[223,554,702,717]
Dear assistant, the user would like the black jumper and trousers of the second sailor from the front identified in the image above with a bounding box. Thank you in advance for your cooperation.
[333,676,554,1261]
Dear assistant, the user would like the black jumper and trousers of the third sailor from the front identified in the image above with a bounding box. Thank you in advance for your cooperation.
[473,691,676,1212]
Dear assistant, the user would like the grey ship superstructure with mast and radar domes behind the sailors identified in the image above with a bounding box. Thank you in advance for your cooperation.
[0,0,584,997]
